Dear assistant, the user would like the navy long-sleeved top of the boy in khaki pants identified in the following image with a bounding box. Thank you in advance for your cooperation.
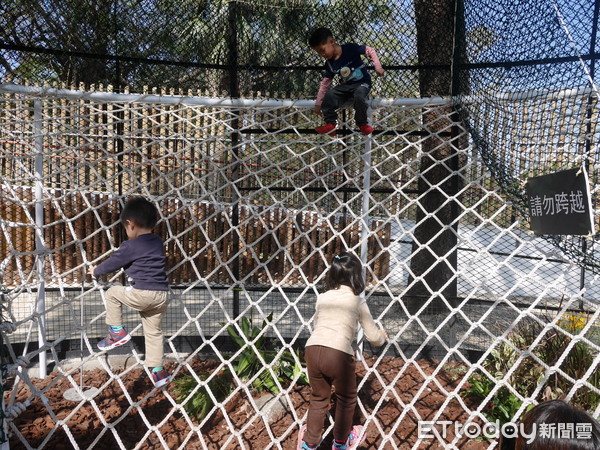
[94,233,169,291]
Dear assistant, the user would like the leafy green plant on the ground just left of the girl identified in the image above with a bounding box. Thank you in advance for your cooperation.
[227,314,308,394]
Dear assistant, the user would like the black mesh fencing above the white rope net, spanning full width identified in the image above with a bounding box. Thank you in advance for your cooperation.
[0,0,598,270]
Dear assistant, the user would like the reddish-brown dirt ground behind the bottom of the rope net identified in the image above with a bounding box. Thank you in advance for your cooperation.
[9,357,491,450]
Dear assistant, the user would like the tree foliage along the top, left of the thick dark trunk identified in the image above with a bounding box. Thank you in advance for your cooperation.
[0,0,417,97]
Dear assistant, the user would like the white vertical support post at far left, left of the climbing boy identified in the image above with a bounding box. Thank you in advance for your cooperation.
[33,99,47,378]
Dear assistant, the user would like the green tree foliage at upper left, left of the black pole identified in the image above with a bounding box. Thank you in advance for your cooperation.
[0,0,227,89]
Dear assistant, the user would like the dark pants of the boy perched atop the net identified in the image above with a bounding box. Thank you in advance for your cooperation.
[321,83,371,127]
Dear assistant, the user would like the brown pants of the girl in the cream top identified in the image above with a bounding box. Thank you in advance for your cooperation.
[304,345,357,444]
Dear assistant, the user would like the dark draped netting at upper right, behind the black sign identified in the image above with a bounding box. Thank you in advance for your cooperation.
[458,0,600,272]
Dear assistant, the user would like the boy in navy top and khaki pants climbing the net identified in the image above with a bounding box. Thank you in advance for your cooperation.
[88,197,171,387]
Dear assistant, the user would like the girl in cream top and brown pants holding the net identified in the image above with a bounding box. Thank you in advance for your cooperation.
[298,252,387,450]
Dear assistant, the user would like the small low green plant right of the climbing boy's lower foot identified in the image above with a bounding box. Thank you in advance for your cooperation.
[173,370,231,420]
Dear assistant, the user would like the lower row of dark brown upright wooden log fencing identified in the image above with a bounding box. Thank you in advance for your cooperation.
[0,187,391,286]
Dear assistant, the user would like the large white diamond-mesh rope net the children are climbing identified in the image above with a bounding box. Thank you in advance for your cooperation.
[0,85,600,449]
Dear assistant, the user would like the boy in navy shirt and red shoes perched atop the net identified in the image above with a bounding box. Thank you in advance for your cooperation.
[308,28,385,136]
